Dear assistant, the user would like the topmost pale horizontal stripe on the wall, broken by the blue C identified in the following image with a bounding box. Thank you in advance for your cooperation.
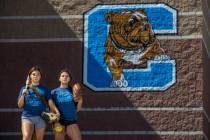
[0,11,203,20]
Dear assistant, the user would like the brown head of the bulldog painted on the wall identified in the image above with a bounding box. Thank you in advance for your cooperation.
[106,10,155,49]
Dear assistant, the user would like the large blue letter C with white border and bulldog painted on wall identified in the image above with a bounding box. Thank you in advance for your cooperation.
[83,4,177,91]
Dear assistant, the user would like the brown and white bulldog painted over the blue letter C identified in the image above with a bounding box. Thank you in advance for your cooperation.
[104,10,165,87]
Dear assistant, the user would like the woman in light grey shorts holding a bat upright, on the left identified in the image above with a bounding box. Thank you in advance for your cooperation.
[17,66,60,140]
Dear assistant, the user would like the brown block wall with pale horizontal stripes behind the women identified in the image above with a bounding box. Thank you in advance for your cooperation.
[0,0,207,140]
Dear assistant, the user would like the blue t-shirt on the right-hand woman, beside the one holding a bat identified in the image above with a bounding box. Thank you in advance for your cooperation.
[51,87,77,121]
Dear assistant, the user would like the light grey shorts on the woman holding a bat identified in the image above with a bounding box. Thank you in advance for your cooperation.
[21,116,46,128]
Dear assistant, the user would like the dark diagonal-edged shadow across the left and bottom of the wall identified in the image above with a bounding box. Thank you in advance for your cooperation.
[0,0,160,140]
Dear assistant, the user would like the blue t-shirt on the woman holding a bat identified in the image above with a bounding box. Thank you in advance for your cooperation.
[18,85,51,117]
